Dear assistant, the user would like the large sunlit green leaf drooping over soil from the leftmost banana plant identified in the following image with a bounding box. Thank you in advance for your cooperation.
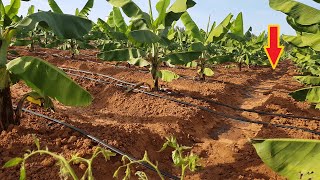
[7,56,92,106]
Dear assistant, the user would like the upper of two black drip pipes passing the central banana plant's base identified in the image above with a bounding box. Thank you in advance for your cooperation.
[61,68,320,121]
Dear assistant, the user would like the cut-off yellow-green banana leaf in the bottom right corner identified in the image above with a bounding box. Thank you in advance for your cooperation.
[251,139,320,180]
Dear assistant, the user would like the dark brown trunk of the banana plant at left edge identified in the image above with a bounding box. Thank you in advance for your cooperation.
[0,67,18,131]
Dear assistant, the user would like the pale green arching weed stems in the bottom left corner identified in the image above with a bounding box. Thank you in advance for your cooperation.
[3,137,116,180]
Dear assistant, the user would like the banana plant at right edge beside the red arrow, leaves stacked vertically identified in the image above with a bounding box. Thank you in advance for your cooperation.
[269,0,320,108]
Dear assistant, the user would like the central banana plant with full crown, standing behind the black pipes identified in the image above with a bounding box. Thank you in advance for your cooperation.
[98,0,199,91]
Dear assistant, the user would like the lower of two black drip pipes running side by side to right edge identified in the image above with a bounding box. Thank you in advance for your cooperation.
[63,69,320,135]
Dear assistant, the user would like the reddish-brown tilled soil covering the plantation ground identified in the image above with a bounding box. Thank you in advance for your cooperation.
[0,48,320,180]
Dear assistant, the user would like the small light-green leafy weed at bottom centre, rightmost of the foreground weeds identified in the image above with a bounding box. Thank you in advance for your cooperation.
[160,136,200,180]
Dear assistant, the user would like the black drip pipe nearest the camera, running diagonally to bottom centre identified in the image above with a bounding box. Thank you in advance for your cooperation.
[22,108,180,180]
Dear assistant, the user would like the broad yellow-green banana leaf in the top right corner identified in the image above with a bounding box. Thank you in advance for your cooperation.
[269,0,320,25]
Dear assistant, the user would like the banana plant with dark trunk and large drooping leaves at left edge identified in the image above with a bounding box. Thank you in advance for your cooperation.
[0,0,92,130]
